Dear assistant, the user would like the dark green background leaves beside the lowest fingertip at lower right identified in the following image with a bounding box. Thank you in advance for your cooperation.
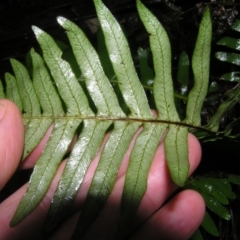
[188,174,240,240]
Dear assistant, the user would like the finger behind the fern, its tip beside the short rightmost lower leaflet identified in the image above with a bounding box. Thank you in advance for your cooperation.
[70,134,201,240]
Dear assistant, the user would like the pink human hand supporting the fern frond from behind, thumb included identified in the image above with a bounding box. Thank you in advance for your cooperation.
[0,100,205,240]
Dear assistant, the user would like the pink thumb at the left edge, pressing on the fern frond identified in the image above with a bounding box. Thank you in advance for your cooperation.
[0,99,24,190]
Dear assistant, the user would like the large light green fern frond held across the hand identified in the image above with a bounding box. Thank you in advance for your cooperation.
[0,0,211,237]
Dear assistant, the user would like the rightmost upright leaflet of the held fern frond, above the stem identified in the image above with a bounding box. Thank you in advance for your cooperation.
[185,7,212,125]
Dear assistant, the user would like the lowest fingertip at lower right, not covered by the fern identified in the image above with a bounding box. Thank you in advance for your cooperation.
[130,190,205,240]
